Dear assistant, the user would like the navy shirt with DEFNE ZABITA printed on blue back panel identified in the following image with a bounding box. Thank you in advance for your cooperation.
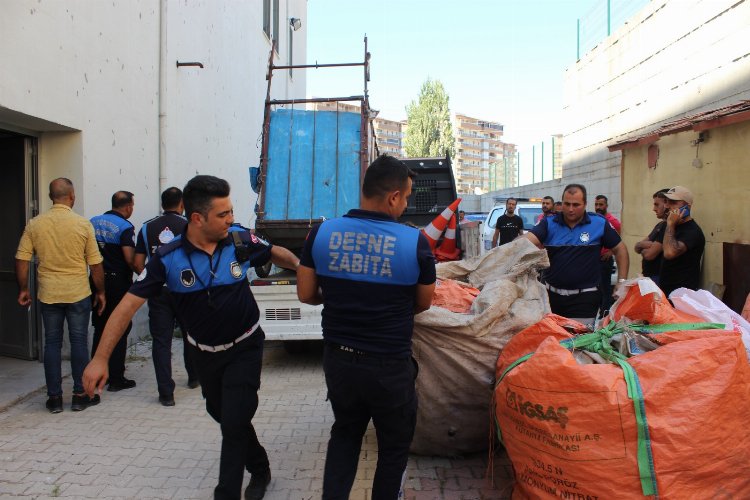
[300,209,435,356]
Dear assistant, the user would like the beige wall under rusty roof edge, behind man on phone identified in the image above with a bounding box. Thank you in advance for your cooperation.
[622,122,750,289]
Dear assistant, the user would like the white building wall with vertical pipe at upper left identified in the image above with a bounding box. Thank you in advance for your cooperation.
[0,0,307,225]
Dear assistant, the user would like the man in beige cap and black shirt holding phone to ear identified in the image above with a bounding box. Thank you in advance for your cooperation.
[659,186,706,297]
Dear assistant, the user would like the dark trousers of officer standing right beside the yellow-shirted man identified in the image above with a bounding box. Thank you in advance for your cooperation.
[91,273,133,383]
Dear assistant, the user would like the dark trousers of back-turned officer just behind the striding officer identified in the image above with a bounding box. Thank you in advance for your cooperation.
[148,287,198,396]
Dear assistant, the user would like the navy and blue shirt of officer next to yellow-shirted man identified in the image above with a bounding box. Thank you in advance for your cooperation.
[91,210,135,276]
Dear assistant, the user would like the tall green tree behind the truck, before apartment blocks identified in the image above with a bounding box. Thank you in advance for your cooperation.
[404,78,455,158]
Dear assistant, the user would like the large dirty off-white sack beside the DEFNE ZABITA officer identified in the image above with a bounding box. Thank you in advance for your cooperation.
[411,239,549,456]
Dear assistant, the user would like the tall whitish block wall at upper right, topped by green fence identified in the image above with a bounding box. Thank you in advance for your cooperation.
[483,0,750,221]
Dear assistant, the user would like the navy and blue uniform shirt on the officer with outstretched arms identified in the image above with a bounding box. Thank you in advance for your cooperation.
[130,228,271,346]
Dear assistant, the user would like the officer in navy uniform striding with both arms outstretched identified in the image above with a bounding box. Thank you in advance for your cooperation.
[84,175,299,499]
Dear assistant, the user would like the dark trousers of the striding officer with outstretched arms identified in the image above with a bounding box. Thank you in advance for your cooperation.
[190,329,269,499]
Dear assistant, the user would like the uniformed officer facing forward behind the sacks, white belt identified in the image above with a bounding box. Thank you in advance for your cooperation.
[524,184,630,323]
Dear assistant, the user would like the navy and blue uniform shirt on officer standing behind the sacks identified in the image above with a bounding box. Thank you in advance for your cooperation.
[530,212,621,290]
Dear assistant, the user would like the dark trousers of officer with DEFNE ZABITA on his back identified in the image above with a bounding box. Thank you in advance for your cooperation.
[323,345,417,500]
